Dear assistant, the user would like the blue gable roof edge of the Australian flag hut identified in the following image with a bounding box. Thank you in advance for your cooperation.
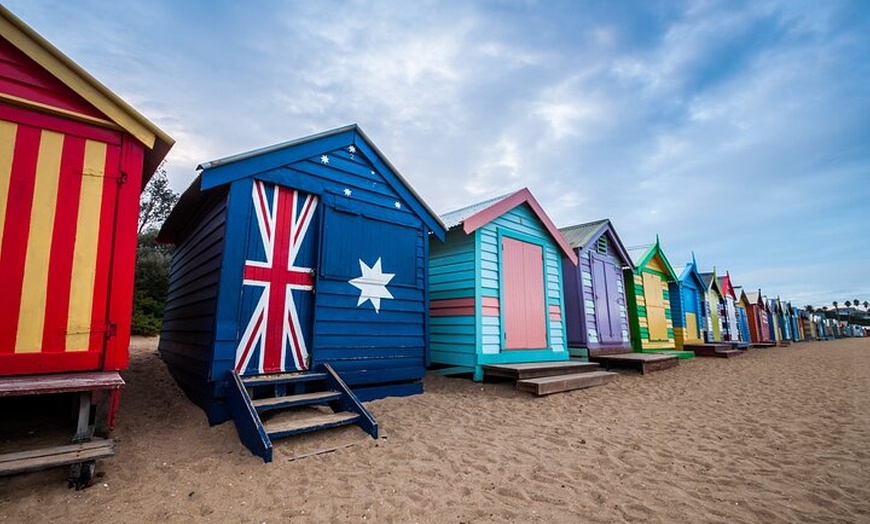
[197,124,446,240]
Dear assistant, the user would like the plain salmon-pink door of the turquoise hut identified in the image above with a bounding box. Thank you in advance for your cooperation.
[501,237,548,349]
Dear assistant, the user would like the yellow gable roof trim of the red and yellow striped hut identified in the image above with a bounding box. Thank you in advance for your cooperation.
[0,5,175,182]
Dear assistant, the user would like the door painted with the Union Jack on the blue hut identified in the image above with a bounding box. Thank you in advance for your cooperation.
[235,180,318,375]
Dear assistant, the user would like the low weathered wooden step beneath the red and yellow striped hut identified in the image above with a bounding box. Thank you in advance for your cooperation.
[0,439,115,476]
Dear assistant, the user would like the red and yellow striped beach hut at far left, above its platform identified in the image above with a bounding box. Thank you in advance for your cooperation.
[0,6,174,376]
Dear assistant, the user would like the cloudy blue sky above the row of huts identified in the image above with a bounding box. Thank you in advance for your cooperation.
[5,0,870,306]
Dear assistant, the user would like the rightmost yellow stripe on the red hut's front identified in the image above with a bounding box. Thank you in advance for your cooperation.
[66,140,106,351]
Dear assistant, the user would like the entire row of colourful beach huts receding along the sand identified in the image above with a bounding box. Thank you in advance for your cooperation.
[0,6,860,470]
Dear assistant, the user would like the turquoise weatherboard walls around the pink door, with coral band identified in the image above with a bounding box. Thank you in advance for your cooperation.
[429,204,568,372]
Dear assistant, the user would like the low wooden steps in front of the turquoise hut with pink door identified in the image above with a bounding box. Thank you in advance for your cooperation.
[483,361,618,397]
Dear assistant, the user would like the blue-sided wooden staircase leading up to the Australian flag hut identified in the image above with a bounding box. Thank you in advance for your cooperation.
[227,364,378,462]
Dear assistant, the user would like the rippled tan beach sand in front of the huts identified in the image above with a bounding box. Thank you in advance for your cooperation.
[0,339,870,523]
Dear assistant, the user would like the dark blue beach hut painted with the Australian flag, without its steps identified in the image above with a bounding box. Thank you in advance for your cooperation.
[159,125,445,422]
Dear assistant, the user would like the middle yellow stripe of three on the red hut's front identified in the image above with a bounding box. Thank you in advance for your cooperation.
[15,131,63,353]
